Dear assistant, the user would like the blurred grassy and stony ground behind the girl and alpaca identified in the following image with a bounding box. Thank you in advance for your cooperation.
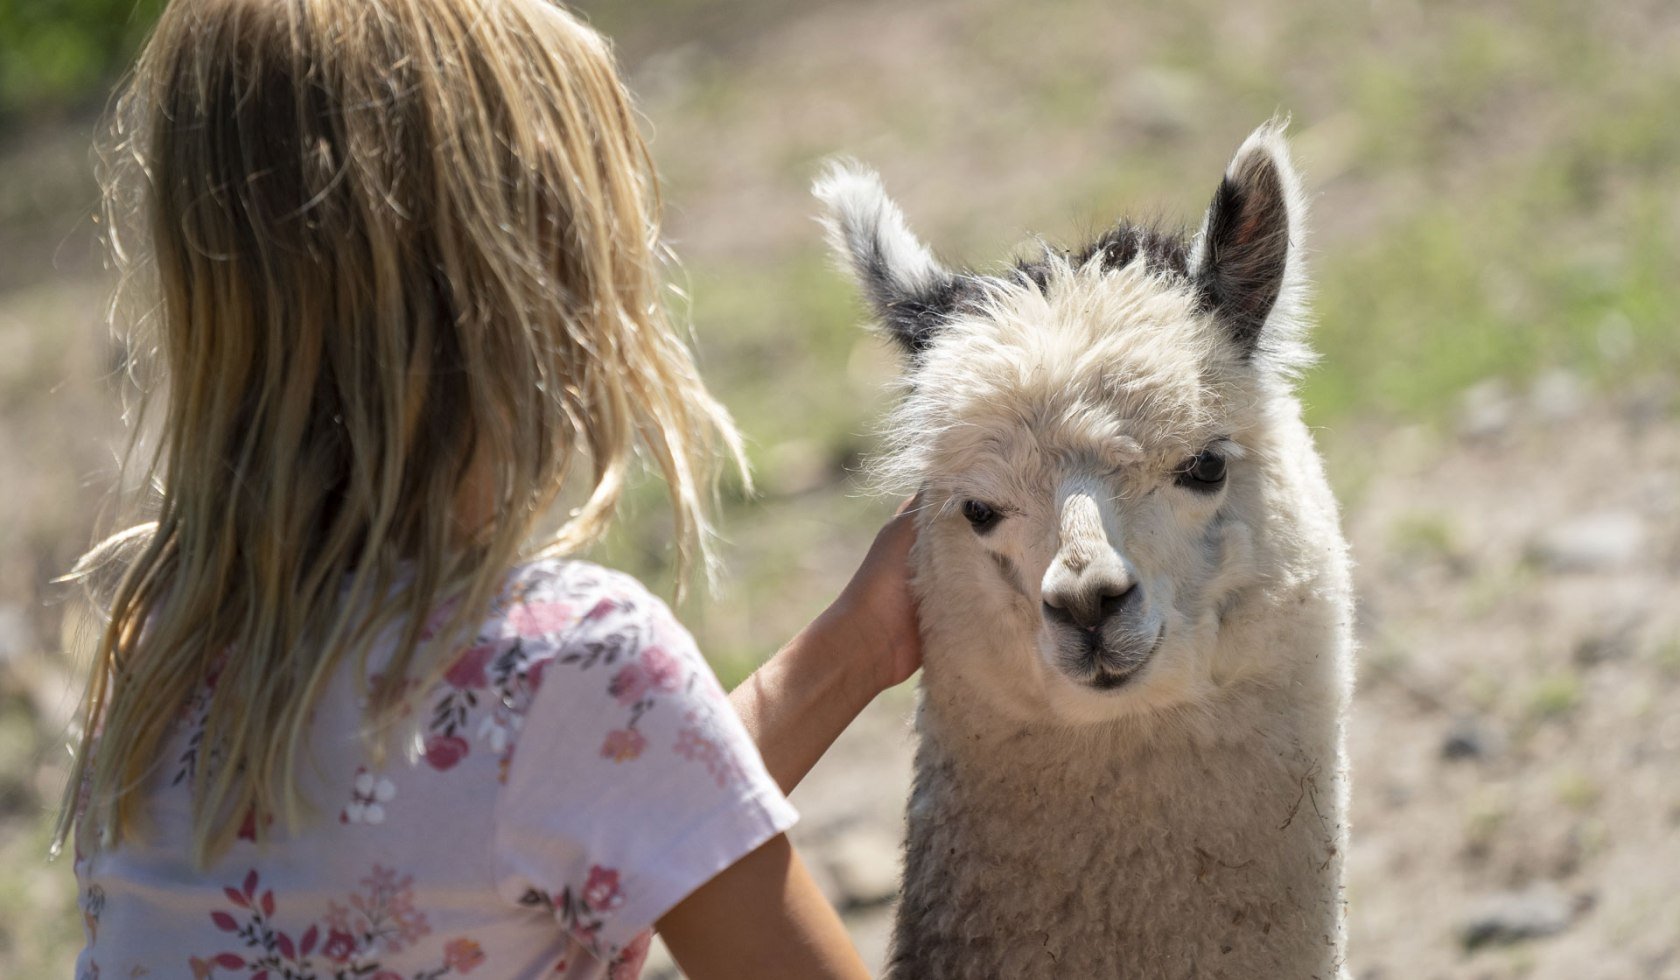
[0,0,1680,980]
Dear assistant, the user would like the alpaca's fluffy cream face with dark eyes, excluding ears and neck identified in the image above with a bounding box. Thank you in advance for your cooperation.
[895,262,1258,721]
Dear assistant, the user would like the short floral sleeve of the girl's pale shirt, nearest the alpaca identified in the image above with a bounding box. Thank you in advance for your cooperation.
[496,570,796,960]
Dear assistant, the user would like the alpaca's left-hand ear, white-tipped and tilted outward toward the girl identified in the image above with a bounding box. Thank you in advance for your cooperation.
[811,161,961,356]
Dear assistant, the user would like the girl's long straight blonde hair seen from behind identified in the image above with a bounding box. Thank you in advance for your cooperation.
[57,0,744,864]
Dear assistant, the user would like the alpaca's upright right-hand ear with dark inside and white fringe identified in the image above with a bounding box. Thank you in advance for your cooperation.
[1191,119,1305,356]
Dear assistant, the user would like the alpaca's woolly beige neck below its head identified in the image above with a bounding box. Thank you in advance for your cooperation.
[894,665,1344,978]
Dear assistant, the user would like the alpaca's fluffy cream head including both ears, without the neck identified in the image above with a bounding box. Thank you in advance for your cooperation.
[816,124,1304,721]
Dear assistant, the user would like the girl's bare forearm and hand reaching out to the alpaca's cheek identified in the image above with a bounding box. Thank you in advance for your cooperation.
[729,498,922,793]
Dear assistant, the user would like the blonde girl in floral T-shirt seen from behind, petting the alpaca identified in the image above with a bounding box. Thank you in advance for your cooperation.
[60,0,919,980]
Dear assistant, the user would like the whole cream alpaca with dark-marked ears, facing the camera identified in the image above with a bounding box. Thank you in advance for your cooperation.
[815,123,1352,980]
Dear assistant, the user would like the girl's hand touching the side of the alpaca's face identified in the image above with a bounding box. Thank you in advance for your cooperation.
[813,496,922,693]
